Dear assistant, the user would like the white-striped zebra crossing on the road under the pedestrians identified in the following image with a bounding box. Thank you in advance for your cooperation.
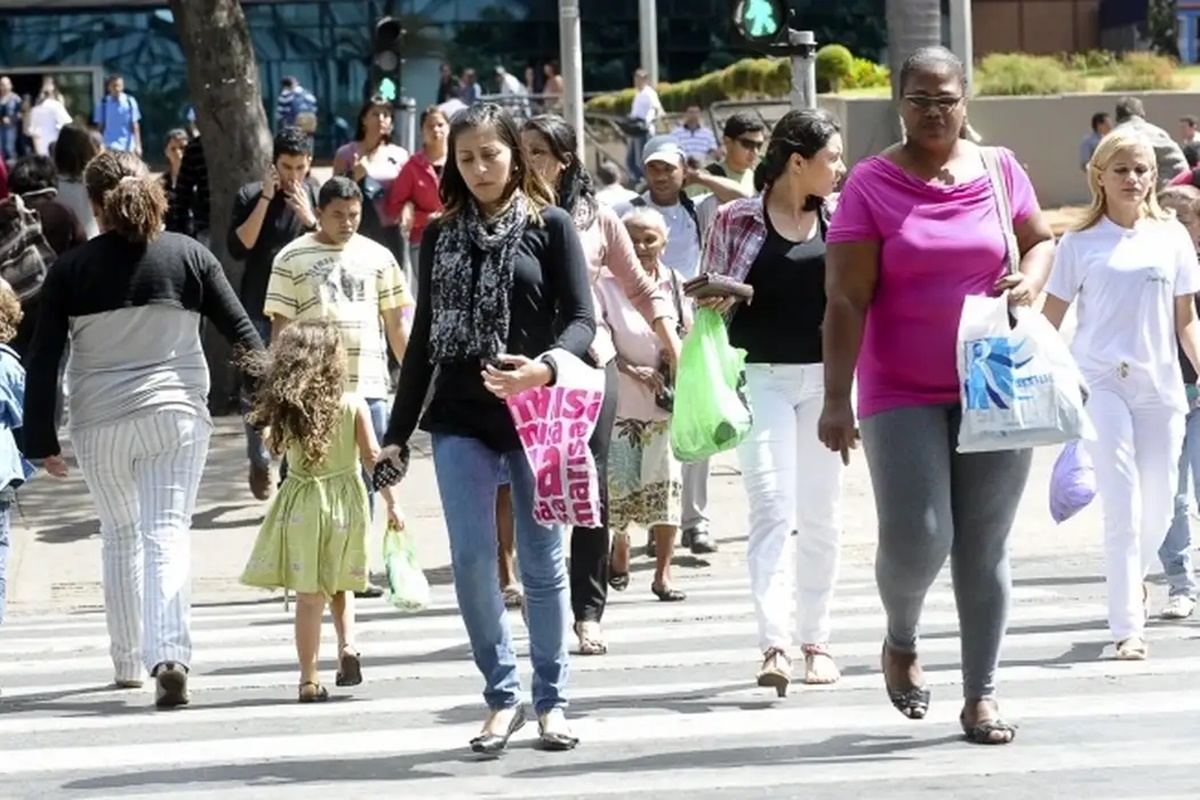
[0,569,1200,800]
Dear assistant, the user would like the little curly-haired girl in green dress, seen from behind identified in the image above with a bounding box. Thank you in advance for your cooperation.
[241,320,403,703]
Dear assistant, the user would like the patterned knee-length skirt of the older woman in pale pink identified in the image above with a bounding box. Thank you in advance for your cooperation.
[608,420,683,534]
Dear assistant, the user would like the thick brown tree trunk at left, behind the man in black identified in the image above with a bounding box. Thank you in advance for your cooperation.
[170,0,271,414]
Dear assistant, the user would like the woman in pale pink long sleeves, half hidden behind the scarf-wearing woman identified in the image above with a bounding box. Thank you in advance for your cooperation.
[522,114,679,655]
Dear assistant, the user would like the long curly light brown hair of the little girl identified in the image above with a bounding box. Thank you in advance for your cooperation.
[245,319,347,464]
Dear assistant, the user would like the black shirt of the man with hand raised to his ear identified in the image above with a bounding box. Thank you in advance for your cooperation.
[227,179,320,317]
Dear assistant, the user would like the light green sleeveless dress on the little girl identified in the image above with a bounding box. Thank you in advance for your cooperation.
[241,396,371,597]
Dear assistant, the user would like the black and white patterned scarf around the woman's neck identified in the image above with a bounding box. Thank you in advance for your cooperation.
[430,191,529,363]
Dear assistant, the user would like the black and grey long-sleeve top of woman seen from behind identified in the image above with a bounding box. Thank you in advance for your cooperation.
[24,233,263,458]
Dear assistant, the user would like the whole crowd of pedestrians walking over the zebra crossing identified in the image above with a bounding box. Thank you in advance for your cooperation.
[0,42,1200,753]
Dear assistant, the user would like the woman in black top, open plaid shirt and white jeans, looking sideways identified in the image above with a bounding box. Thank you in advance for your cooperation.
[706,110,845,696]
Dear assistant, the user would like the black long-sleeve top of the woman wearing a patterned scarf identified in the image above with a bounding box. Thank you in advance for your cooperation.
[384,207,595,452]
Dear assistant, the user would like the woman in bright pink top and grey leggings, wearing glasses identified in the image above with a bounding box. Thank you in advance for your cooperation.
[818,47,1054,745]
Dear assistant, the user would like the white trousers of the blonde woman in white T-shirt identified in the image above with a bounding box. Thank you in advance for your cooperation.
[1085,378,1186,642]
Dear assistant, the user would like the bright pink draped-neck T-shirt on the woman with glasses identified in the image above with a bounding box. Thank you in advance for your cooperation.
[826,149,1038,417]
